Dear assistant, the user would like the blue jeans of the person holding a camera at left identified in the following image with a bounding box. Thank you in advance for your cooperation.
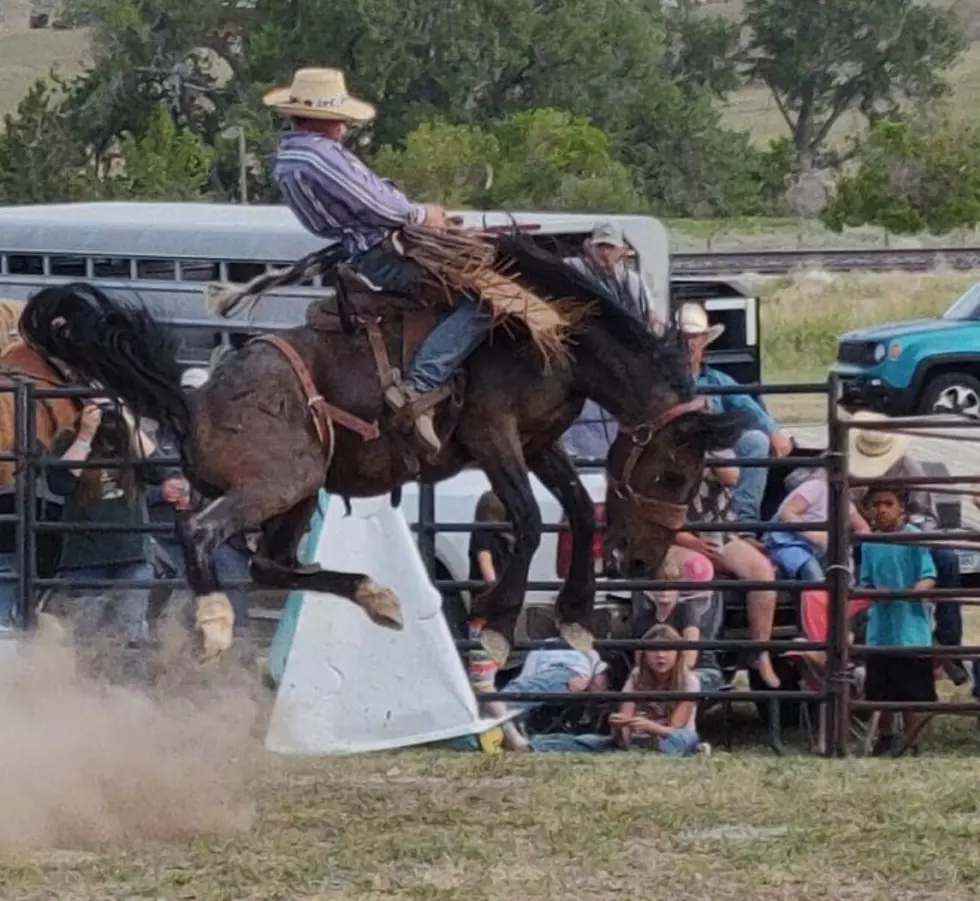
[58,561,153,646]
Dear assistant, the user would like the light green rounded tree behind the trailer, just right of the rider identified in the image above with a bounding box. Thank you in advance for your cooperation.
[376,109,639,211]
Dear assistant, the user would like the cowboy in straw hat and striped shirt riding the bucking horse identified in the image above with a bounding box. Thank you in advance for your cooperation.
[263,69,492,455]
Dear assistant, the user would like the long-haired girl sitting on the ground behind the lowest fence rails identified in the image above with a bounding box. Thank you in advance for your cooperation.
[609,624,711,755]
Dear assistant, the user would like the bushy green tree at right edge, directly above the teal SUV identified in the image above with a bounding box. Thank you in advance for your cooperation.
[822,121,980,235]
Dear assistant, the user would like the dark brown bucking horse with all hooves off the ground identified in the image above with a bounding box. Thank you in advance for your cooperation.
[20,235,740,663]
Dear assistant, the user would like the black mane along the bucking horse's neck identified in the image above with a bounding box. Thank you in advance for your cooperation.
[496,232,693,396]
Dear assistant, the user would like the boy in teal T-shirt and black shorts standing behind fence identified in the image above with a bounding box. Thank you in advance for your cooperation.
[858,485,936,757]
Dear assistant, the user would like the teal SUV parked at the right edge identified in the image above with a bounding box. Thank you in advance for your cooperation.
[833,282,980,419]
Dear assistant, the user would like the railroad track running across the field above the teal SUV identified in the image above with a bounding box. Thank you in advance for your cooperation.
[671,247,980,276]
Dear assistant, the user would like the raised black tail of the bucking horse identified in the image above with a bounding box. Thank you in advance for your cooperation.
[20,282,191,446]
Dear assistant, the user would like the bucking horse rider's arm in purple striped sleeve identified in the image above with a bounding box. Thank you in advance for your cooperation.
[288,141,429,228]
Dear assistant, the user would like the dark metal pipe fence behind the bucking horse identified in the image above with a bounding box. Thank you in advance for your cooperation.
[0,376,980,756]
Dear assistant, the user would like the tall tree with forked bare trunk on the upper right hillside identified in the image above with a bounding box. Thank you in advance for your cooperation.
[745,0,965,169]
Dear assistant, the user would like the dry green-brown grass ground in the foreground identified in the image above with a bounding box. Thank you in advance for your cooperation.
[0,740,980,901]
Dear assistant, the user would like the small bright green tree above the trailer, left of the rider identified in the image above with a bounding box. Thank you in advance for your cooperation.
[109,106,214,200]
